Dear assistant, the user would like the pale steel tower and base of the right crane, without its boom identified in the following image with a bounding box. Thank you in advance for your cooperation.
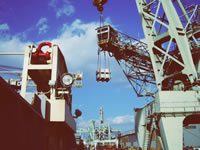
[136,0,200,150]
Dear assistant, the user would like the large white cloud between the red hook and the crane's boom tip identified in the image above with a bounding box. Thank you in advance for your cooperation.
[52,19,97,72]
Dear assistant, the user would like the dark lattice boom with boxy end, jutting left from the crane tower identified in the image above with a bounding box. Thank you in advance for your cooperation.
[96,25,157,97]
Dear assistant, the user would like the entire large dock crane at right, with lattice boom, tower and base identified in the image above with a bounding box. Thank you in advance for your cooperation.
[93,0,200,150]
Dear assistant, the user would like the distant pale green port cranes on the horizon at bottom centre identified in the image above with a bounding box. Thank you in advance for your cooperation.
[77,107,120,150]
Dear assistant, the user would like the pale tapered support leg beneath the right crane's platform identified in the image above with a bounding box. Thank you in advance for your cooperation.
[159,116,185,150]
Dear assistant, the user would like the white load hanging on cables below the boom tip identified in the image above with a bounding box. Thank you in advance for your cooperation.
[96,68,111,82]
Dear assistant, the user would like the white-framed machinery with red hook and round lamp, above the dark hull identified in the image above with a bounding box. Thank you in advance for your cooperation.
[0,42,83,132]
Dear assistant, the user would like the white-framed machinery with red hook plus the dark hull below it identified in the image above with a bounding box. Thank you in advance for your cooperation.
[0,42,82,150]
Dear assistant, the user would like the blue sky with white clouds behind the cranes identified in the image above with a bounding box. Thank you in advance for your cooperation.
[0,0,149,131]
